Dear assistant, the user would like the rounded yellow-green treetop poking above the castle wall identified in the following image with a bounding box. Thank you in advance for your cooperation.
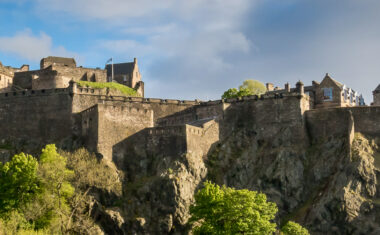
[222,80,266,99]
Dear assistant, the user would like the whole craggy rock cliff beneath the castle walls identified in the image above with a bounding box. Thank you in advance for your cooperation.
[94,116,380,234]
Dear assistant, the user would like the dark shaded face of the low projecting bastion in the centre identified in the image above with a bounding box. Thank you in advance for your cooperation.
[112,125,187,175]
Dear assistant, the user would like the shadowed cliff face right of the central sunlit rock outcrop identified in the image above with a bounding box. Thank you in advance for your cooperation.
[209,131,380,234]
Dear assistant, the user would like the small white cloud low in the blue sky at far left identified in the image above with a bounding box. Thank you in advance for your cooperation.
[0,29,75,62]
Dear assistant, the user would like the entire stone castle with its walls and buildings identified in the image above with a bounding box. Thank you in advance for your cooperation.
[0,57,380,167]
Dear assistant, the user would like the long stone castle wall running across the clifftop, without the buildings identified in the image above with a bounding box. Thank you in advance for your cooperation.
[0,80,380,170]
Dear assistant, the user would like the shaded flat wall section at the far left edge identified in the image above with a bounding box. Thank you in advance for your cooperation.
[0,89,73,148]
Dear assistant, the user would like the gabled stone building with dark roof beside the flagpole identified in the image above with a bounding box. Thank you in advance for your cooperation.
[106,58,144,96]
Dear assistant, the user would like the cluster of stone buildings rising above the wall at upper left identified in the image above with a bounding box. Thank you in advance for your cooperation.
[7,56,144,96]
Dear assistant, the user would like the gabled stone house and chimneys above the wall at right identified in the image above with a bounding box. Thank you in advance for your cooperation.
[266,74,364,109]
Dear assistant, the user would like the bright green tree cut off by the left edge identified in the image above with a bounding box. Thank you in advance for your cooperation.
[0,153,39,215]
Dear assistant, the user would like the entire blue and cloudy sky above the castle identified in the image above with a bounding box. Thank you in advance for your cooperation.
[0,0,380,103]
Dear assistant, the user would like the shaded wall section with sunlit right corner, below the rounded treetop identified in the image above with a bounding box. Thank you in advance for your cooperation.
[220,93,309,144]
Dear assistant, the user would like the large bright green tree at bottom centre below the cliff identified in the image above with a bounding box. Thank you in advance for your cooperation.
[190,182,277,234]
